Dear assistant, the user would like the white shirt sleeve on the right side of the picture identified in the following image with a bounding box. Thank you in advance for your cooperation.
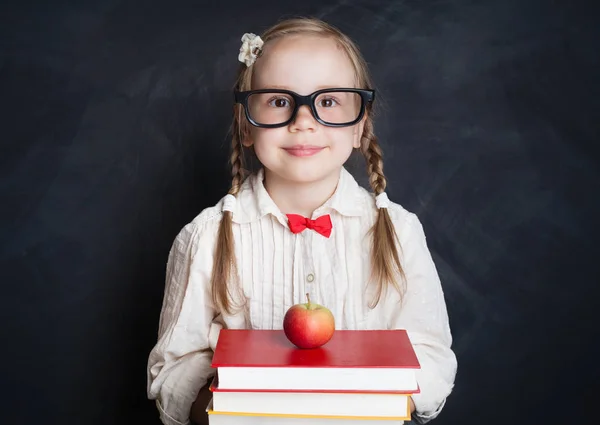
[391,214,457,423]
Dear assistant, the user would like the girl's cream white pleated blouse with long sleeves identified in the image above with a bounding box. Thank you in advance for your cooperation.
[147,168,457,425]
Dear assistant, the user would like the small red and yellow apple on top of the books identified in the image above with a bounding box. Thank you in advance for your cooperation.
[283,294,335,348]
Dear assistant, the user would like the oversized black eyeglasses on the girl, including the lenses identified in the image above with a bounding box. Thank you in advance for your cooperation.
[234,88,375,128]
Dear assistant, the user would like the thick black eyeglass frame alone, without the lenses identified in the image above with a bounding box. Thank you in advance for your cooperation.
[233,88,375,128]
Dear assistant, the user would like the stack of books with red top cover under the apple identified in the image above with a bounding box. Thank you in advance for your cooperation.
[206,329,420,425]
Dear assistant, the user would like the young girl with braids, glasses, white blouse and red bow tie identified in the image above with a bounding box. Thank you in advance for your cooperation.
[148,19,457,425]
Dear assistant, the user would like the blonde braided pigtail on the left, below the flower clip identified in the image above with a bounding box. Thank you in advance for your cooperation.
[210,112,245,313]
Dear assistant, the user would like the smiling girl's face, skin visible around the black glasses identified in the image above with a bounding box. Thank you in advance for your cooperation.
[244,35,364,188]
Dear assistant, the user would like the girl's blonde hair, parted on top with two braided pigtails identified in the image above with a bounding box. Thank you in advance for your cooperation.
[211,18,404,312]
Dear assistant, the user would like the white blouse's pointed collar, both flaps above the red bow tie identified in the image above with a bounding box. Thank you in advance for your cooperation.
[233,167,366,224]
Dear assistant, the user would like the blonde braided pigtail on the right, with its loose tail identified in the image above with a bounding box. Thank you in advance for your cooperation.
[361,119,404,307]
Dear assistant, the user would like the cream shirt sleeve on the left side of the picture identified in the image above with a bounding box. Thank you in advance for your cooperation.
[147,222,219,425]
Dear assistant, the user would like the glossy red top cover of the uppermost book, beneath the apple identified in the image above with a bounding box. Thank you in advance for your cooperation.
[212,329,420,369]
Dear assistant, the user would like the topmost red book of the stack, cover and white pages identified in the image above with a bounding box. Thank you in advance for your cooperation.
[212,329,420,392]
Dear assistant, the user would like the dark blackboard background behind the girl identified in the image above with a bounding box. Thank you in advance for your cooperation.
[0,0,600,425]
